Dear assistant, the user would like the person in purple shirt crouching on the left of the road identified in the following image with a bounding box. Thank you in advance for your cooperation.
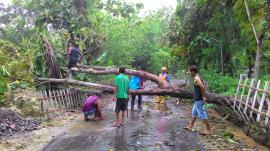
[82,93,103,121]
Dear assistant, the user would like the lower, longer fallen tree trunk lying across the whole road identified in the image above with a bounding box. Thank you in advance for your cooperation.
[38,78,233,105]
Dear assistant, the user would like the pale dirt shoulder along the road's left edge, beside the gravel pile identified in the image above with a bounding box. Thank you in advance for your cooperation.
[0,112,81,151]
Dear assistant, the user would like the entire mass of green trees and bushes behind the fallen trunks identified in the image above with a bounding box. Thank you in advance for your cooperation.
[0,0,270,100]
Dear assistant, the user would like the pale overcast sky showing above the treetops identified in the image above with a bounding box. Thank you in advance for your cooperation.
[0,0,177,11]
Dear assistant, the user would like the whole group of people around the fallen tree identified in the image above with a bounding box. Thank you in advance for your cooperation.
[67,44,212,135]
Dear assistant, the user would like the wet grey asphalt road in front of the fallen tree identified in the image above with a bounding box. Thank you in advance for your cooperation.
[43,96,204,151]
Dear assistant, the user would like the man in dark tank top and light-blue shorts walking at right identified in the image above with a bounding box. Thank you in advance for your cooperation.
[184,65,212,135]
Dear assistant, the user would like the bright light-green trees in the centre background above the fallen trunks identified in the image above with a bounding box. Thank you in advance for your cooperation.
[96,10,171,73]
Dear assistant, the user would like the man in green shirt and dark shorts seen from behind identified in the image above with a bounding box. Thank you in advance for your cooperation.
[113,67,129,127]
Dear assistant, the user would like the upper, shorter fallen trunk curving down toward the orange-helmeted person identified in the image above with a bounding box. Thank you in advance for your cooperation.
[63,65,166,88]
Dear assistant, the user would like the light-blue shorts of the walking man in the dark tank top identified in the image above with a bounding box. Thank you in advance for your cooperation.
[192,101,208,120]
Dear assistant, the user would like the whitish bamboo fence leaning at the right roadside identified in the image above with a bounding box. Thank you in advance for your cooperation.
[233,77,270,125]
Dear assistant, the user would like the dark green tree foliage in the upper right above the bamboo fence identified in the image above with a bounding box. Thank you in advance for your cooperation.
[169,0,270,76]
